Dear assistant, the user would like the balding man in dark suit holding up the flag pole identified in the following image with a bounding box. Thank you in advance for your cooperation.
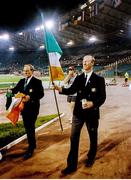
[54,55,106,175]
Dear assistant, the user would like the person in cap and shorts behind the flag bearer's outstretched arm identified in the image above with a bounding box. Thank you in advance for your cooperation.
[64,66,77,123]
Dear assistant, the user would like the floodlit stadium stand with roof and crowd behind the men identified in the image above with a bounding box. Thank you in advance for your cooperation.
[0,0,131,76]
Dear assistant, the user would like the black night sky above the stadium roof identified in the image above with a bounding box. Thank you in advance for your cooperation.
[0,0,85,31]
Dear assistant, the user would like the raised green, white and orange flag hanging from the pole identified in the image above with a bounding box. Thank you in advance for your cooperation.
[44,22,64,81]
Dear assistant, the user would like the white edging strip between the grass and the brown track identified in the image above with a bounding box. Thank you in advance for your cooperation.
[0,113,65,151]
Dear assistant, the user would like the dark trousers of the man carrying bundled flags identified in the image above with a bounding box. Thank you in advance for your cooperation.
[22,113,37,151]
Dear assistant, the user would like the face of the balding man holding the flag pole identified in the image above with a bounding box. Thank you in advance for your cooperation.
[83,56,94,71]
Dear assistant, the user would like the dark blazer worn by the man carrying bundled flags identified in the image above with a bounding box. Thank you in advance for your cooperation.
[12,77,44,114]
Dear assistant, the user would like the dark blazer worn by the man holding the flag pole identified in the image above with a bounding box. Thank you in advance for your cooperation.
[62,72,106,121]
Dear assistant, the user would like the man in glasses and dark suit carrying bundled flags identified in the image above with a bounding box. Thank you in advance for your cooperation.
[12,64,44,159]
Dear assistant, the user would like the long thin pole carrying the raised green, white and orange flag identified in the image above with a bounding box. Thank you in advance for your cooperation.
[41,13,63,132]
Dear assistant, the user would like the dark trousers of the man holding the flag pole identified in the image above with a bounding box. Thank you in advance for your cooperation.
[67,116,98,169]
